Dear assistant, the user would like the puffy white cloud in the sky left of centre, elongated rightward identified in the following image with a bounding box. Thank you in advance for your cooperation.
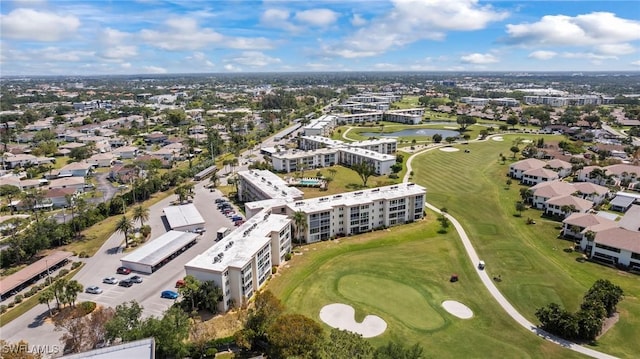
[140,17,271,51]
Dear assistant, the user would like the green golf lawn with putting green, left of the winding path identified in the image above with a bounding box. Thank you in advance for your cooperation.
[268,212,580,358]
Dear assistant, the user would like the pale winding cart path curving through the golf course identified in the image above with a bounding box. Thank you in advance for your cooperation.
[402,145,616,359]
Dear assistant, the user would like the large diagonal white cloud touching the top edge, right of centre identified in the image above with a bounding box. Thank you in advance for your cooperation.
[325,0,508,57]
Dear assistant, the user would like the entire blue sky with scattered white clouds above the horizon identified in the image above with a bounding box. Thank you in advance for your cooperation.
[0,0,640,76]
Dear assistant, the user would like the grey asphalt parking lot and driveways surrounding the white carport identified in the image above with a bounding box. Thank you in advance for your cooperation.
[1,182,235,352]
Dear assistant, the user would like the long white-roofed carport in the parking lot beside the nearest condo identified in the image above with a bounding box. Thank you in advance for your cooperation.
[120,231,198,274]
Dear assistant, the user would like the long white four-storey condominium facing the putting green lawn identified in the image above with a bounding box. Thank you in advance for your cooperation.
[284,183,426,243]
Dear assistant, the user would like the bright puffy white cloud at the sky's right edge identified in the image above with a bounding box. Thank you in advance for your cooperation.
[507,12,640,46]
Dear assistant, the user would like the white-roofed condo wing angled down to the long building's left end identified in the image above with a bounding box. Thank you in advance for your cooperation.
[238,170,304,202]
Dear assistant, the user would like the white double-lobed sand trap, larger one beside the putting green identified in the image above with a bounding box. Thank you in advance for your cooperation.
[320,303,387,338]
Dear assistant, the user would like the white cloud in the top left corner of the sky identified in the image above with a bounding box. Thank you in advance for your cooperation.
[0,8,80,42]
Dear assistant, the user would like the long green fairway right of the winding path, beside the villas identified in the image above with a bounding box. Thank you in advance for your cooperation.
[413,134,640,357]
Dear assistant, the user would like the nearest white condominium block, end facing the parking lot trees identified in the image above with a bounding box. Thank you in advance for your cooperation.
[185,209,291,311]
